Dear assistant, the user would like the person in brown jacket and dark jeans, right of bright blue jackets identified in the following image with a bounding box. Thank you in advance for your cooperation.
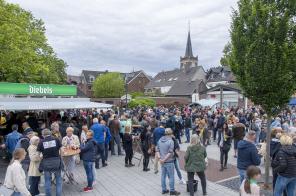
[109,115,121,156]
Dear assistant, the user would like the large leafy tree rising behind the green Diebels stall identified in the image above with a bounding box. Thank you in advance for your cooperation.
[0,0,66,83]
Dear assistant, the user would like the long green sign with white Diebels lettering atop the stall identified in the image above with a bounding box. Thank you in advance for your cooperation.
[0,82,77,96]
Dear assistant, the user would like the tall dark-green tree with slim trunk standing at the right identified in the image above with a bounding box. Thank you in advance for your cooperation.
[229,0,296,186]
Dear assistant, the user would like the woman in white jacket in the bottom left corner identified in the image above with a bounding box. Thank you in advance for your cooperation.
[4,148,31,196]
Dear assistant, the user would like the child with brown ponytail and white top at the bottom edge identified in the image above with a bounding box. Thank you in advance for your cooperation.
[240,165,261,196]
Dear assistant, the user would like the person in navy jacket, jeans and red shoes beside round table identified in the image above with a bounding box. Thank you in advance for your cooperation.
[80,131,97,192]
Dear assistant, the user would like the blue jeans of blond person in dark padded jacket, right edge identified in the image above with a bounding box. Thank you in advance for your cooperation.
[274,175,296,196]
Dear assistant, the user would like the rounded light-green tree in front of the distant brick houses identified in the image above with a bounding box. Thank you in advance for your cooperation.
[93,72,124,98]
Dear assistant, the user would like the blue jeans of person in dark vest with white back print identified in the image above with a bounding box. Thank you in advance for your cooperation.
[44,171,62,196]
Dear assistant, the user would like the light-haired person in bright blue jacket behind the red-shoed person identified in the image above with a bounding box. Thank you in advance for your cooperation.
[90,118,107,169]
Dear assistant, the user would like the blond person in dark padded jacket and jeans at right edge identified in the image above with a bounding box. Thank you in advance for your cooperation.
[272,135,296,196]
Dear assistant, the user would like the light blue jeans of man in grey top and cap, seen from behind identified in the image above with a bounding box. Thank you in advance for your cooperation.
[161,162,175,191]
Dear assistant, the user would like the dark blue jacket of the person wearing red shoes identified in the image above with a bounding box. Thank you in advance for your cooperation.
[80,139,97,162]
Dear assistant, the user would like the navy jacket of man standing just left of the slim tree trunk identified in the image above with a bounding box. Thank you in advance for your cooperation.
[237,140,261,170]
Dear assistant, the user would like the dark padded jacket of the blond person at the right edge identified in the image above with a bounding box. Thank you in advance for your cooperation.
[272,145,296,178]
